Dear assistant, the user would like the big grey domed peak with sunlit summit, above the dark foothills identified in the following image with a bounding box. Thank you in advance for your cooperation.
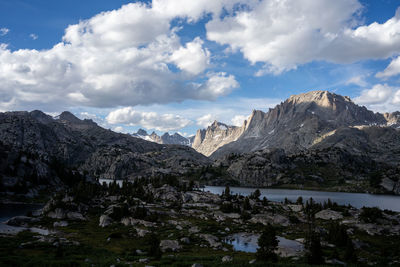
[211,91,400,159]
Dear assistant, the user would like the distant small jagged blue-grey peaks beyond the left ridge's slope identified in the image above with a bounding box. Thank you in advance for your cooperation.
[132,129,193,146]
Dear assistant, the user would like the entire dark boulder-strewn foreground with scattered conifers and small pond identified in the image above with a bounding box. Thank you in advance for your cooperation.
[0,179,400,266]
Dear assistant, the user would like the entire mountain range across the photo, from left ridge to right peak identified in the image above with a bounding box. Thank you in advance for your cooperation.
[0,91,400,198]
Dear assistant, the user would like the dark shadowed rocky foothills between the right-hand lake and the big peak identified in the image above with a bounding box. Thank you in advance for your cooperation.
[214,146,400,194]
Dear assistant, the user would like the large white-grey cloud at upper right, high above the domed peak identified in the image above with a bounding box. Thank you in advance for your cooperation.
[206,0,400,76]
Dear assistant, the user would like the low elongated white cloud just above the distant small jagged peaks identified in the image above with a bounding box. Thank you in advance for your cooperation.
[106,107,191,132]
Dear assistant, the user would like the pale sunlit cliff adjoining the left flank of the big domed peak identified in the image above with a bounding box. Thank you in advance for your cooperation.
[192,121,246,156]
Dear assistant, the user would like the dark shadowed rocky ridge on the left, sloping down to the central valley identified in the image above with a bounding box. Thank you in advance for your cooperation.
[0,111,209,197]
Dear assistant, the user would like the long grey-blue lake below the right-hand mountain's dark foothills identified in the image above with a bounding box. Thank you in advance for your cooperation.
[204,186,400,212]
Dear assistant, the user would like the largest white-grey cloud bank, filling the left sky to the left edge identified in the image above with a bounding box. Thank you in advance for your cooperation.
[0,0,238,110]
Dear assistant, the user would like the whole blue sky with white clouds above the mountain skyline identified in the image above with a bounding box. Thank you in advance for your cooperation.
[0,0,400,136]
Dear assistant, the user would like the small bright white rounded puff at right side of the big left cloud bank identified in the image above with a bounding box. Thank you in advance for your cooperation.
[171,37,210,75]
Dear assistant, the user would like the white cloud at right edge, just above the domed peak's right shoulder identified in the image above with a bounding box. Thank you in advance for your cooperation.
[354,84,400,112]
